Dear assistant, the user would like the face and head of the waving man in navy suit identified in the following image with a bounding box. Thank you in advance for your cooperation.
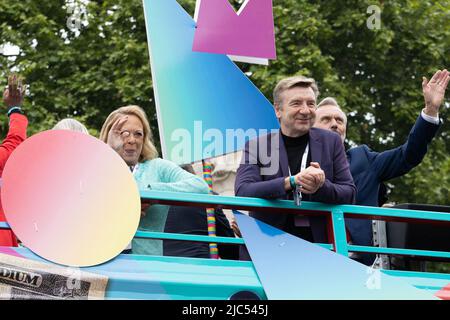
[314,105,347,142]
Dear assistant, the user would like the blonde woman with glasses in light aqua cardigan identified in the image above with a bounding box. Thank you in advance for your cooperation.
[100,106,209,255]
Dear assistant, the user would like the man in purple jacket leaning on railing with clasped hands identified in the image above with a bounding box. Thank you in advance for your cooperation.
[235,76,356,242]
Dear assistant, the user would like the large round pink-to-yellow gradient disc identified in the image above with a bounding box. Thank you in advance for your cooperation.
[1,130,140,267]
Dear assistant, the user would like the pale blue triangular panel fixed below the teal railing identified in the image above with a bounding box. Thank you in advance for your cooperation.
[234,211,438,300]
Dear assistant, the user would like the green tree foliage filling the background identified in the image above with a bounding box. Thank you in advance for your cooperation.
[0,0,450,205]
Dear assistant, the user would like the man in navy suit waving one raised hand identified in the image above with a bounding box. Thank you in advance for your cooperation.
[314,70,450,265]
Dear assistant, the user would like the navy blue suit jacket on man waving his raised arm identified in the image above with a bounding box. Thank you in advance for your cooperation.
[346,116,440,264]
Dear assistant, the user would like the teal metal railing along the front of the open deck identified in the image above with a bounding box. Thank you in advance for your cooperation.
[0,191,450,259]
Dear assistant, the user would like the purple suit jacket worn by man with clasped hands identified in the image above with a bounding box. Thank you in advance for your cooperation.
[235,128,356,242]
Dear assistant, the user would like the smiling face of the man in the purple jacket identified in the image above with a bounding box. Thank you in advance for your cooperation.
[275,87,316,137]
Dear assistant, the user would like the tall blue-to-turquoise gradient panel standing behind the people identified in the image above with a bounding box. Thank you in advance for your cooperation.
[144,0,279,164]
